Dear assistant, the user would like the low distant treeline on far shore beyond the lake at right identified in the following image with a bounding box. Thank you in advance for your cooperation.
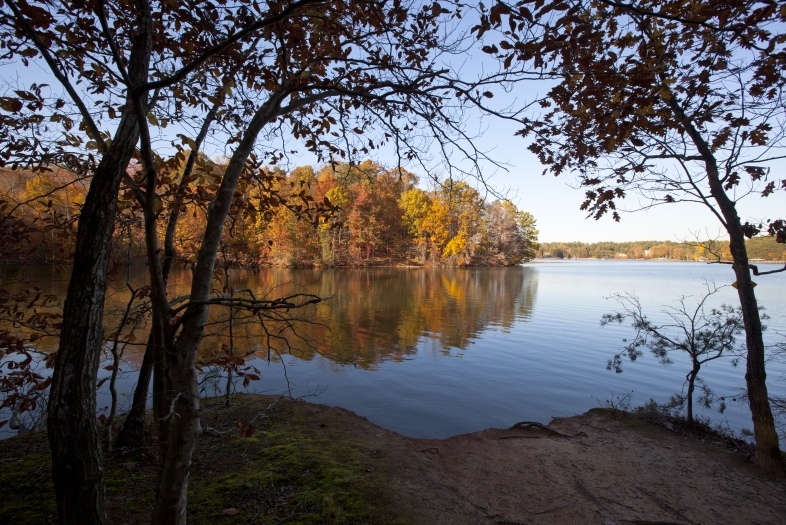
[537,236,786,261]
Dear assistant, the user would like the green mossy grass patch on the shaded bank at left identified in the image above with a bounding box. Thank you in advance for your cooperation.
[0,395,409,525]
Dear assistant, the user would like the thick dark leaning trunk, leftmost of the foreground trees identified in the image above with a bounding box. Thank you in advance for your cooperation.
[47,118,139,525]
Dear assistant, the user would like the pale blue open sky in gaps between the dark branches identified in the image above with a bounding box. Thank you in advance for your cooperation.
[0,10,786,243]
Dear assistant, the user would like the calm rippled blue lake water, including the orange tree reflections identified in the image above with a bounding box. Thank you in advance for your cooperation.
[3,261,786,438]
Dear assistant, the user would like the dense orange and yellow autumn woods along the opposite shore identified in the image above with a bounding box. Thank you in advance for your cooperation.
[0,158,538,267]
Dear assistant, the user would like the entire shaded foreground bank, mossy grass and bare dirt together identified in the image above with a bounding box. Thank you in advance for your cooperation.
[0,394,784,525]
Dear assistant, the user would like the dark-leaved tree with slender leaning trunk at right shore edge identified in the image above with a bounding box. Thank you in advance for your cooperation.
[475,0,786,477]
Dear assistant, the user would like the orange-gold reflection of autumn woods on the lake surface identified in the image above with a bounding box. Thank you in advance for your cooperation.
[0,266,538,369]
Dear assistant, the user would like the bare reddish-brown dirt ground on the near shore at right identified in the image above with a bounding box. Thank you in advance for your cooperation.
[344,410,786,525]
